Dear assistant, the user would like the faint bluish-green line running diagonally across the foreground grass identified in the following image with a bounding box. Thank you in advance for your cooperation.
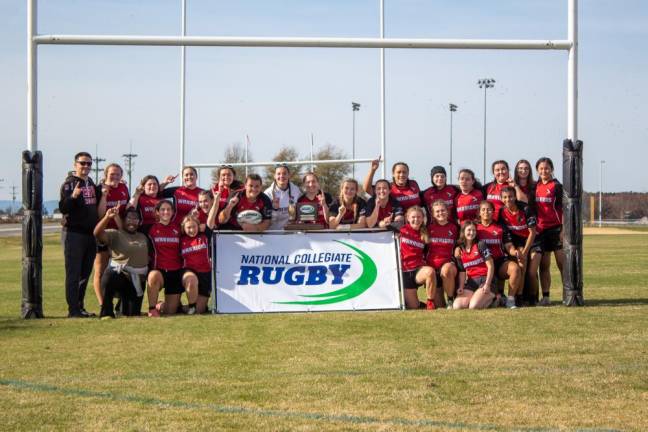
[0,379,619,432]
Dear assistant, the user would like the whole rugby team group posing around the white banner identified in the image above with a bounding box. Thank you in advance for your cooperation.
[59,152,565,319]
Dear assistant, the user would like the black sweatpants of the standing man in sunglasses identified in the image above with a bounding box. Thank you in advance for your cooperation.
[61,229,97,315]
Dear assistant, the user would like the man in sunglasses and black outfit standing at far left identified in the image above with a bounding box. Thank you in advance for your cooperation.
[59,152,106,318]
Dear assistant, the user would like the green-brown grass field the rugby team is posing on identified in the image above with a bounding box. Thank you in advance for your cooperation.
[0,235,648,431]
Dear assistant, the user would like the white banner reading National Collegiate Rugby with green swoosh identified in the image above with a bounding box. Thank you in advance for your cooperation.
[214,231,400,313]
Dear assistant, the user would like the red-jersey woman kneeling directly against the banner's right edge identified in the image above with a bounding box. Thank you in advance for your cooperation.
[400,206,436,310]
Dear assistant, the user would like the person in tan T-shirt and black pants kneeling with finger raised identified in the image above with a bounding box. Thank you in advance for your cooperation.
[94,206,148,318]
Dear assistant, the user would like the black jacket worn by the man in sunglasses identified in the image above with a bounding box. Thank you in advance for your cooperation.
[59,175,101,235]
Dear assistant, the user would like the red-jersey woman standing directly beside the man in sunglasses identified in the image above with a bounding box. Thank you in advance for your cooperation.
[92,163,130,306]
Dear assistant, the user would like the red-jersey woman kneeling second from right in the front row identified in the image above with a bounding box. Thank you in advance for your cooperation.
[477,201,524,308]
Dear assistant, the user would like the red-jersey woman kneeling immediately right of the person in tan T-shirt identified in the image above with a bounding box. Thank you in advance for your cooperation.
[147,200,184,317]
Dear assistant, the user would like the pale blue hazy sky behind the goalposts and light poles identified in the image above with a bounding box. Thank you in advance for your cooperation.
[0,0,648,199]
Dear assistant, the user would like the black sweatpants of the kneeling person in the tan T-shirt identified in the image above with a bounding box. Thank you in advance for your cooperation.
[101,267,146,316]
